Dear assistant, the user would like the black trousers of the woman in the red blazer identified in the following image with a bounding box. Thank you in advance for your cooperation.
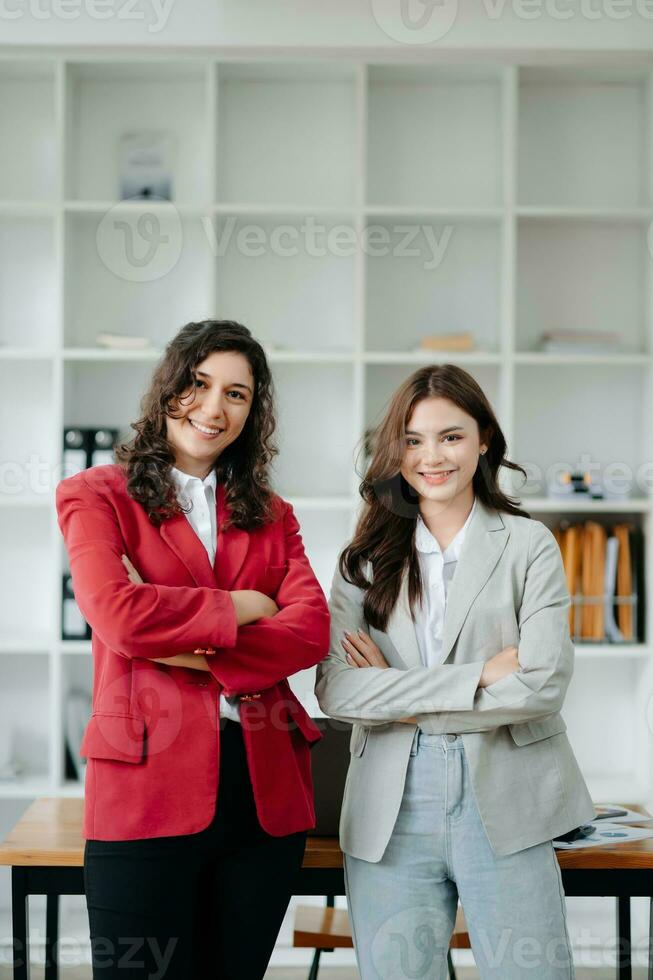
[84,720,306,980]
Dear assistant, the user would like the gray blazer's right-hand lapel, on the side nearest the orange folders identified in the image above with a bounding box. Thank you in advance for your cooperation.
[440,499,510,663]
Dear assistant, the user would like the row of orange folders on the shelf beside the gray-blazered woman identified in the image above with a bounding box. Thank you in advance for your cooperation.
[553,521,642,643]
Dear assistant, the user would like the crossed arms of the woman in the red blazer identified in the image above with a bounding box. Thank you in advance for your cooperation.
[56,473,329,696]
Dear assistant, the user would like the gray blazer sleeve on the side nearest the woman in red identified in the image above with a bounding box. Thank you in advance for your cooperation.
[315,568,483,726]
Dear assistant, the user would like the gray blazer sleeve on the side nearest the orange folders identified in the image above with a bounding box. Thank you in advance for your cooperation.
[417,521,574,734]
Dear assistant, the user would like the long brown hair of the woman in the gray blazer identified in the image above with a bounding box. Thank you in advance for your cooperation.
[339,364,530,630]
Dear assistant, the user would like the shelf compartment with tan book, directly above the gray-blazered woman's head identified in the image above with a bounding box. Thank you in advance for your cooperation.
[364,217,501,360]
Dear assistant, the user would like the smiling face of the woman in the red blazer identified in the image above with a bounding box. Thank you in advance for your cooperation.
[166,351,254,479]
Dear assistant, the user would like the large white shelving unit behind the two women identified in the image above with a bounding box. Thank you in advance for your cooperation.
[0,50,653,828]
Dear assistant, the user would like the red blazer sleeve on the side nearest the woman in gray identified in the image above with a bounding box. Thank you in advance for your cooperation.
[206,504,329,697]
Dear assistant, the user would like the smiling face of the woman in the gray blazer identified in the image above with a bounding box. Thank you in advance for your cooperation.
[401,397,487,512]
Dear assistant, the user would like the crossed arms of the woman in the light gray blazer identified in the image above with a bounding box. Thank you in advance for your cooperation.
[315,521,573,734]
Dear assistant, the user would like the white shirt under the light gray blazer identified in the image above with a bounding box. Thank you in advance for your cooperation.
[415,497,476,667]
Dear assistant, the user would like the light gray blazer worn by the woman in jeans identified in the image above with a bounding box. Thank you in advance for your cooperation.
[315,500,594,861]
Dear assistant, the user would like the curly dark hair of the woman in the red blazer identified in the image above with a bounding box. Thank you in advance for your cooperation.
[115,320,278,530]
